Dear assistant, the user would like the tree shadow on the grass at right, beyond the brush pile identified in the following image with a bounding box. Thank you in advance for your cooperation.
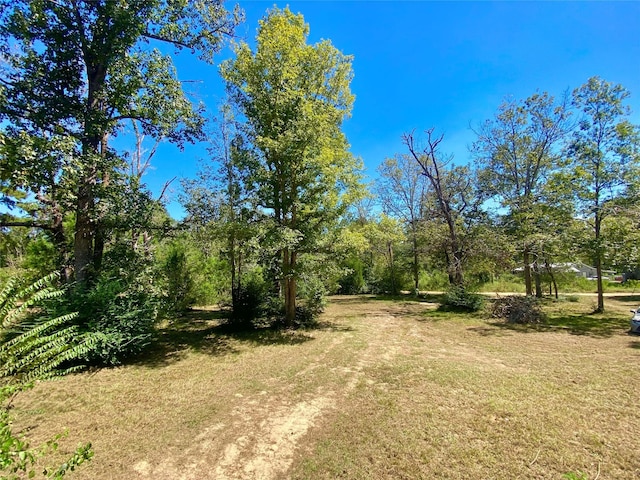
[469,314,629,338]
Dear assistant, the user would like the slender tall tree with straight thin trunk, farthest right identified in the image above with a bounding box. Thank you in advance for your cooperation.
[568,77,640,312]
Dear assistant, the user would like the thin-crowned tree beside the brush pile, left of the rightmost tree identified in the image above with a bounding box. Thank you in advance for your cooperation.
[472,92,568,295]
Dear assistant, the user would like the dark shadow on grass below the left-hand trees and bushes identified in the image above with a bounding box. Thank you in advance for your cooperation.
[132,309,318,367]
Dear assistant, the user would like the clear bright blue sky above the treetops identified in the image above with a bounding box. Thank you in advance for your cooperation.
[145,0,640,217]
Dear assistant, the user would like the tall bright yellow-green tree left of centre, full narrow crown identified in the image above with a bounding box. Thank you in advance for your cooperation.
[222,8,358,325]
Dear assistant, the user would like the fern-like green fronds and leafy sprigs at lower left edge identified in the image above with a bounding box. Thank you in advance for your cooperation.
[0,274,95,480]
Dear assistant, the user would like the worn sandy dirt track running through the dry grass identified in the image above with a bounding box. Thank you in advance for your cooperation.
[129,300,429,480]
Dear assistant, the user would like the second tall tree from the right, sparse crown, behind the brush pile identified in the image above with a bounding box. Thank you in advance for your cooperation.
[472,92,572,294]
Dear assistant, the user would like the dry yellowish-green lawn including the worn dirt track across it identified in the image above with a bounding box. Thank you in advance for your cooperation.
[14,295,640,480]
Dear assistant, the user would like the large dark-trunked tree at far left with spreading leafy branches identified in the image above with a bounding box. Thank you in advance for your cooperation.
[0,0,240,284]
